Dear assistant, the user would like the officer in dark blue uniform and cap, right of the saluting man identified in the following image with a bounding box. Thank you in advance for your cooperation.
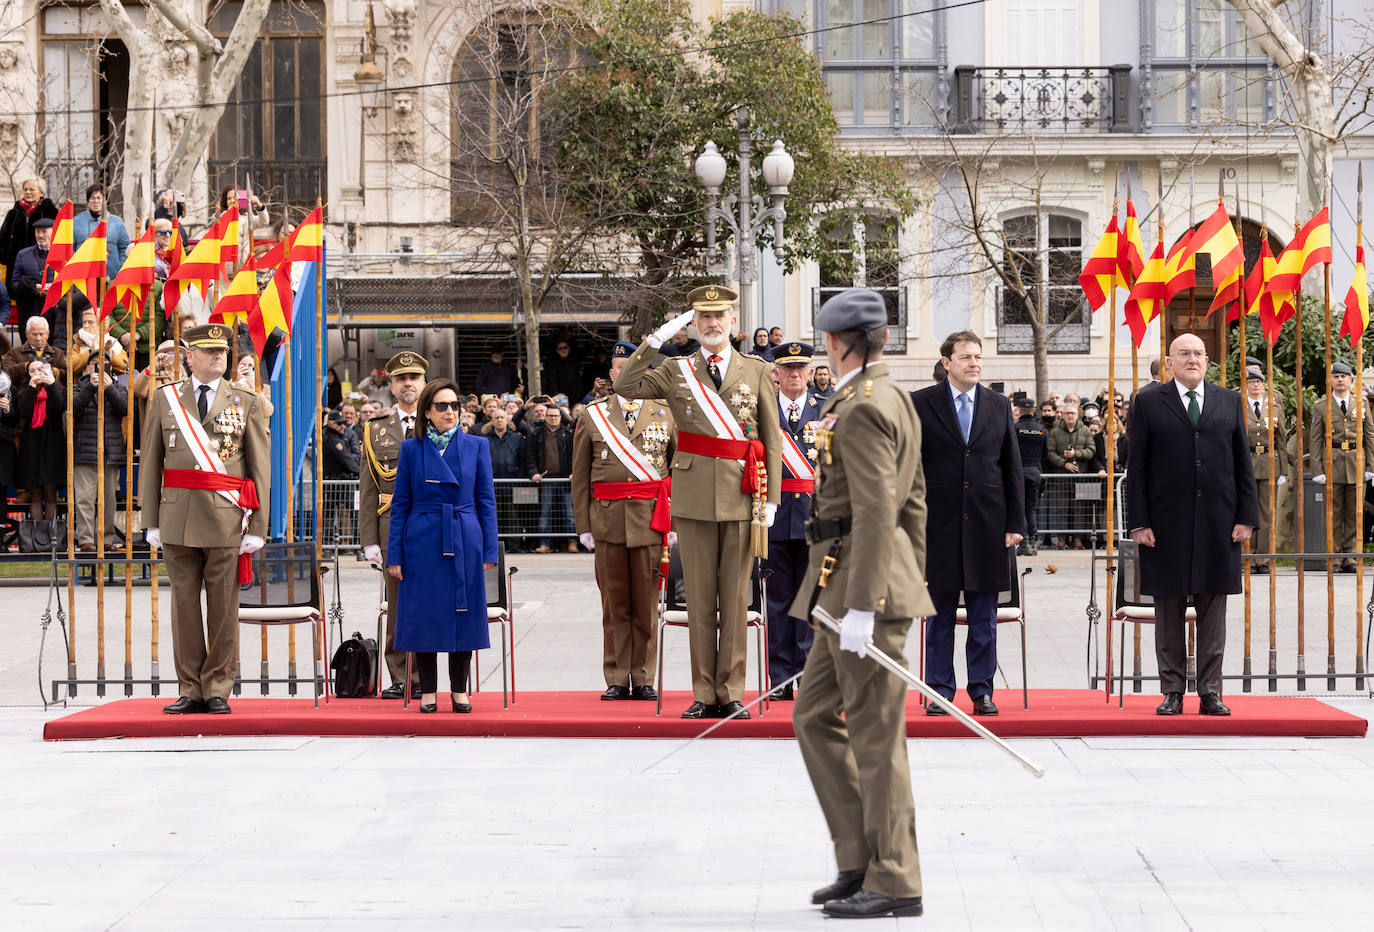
[767,342,822,700]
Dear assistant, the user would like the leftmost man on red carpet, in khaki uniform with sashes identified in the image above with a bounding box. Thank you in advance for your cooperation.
[139,323,272,715]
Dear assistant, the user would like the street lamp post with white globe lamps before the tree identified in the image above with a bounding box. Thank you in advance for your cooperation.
[694,107,796,334]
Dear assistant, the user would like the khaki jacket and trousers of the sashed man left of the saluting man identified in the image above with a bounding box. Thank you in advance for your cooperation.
[572,397,673,686]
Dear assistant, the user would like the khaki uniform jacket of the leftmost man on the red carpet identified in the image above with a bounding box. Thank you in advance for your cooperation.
[139,377,272,547]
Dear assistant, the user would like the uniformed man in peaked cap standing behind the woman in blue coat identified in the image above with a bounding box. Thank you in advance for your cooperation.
[357,352,429,698]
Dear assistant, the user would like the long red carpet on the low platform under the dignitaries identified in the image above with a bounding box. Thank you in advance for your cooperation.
[43,690,1369,741]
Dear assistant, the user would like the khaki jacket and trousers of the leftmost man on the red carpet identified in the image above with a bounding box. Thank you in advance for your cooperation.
[139,377,272,701]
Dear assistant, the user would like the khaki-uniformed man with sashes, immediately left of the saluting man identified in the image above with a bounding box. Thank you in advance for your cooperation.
[572,342,673,700]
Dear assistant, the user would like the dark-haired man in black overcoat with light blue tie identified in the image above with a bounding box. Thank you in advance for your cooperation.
[911,330,1025,715]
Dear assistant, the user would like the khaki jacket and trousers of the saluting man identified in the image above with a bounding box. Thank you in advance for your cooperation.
[616,342,782,705]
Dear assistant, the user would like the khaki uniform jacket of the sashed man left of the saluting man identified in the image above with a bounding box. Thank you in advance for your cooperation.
[572,396,675,547]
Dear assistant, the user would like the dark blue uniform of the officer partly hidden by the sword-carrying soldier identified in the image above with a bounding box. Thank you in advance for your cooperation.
[768,393,820,685]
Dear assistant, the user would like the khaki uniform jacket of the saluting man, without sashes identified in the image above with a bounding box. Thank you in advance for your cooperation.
[616,342,782,521]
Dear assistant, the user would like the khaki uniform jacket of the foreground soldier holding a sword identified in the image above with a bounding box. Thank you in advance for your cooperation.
[791,363,934,619]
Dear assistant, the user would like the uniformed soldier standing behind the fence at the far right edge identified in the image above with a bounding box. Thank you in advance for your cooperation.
[1307,363,1374,573]
